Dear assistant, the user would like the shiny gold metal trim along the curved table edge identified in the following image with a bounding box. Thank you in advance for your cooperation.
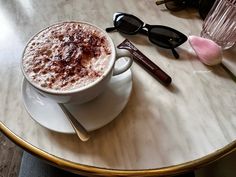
[0,121,236,176]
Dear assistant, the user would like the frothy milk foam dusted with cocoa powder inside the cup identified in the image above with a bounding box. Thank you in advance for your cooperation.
[23,22,111,90]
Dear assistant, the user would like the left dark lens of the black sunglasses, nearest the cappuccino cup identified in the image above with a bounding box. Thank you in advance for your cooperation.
[115,15,143,34]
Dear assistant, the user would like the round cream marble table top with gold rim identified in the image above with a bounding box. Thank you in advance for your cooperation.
[0,0,236,175]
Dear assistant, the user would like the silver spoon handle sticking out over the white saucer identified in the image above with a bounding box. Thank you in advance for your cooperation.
[58,103,90,141]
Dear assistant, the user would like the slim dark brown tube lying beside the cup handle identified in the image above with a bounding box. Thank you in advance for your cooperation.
[117,39,171,86]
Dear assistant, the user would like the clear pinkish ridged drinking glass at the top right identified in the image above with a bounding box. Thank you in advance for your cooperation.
[201,0,236,49]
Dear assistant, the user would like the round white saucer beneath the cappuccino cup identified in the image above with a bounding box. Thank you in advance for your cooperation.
[22,64,132,133]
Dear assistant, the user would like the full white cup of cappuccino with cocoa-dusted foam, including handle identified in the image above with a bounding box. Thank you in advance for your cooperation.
[21,22,132,103]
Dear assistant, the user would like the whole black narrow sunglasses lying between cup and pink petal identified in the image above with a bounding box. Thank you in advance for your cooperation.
[106,13,187,58]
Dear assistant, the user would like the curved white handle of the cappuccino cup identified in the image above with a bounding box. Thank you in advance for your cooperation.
[113,49,133,76]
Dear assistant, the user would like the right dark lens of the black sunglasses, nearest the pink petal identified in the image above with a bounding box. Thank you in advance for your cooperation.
[149,27,187,49]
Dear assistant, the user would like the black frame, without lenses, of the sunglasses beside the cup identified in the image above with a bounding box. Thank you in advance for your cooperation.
[106,12,187,58]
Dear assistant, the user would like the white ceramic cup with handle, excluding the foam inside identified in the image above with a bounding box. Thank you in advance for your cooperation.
[21,22,133,103]
